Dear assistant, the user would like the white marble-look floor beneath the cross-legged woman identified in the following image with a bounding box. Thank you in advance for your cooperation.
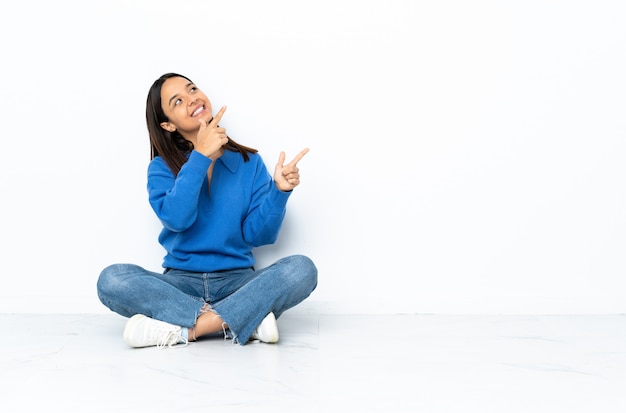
[0,312,626,413]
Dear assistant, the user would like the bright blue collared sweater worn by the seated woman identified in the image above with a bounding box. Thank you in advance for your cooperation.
[148,151,291,272]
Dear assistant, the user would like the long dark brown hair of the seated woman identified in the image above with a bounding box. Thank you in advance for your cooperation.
[146,73,258,176]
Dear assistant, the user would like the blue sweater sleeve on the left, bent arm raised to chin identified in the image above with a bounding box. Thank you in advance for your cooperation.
[148,151,212,232]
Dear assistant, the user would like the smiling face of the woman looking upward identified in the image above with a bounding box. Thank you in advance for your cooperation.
[161,77,213,138]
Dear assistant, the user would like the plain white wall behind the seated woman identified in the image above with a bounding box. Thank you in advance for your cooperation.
[0,0,626,313]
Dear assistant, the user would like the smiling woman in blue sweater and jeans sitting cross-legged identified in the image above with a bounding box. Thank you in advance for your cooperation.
[97,73,317,347]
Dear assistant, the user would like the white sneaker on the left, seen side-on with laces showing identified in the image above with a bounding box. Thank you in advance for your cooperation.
[124,314,187,348]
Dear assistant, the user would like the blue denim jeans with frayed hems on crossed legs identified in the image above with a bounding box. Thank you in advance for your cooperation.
[97,255,317,345]
